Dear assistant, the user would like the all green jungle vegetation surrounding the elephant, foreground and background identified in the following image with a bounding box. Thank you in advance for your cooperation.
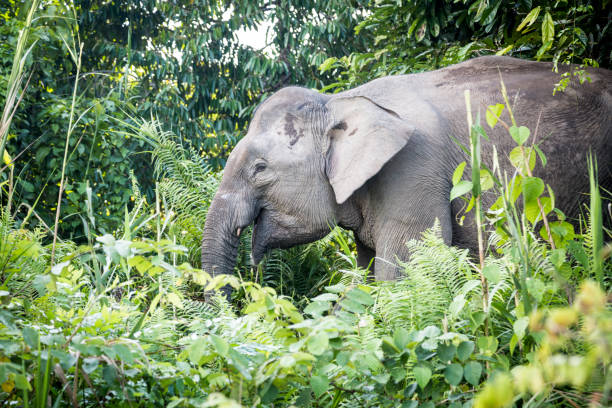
[0,0,612,408]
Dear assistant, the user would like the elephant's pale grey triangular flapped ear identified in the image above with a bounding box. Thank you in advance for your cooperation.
[324,96,414,204]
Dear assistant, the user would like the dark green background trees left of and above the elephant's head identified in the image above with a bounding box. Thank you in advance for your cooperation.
[0,0,365,237]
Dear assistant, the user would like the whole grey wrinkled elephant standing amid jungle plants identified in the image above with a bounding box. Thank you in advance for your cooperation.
[202,57,612,286]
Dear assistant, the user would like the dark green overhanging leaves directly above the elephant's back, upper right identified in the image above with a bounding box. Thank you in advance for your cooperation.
[320,0,612,89]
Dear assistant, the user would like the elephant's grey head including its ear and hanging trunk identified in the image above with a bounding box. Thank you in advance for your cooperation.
[202,87,412,275]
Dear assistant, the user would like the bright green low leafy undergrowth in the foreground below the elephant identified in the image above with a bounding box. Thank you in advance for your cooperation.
[0,203,610,407]
